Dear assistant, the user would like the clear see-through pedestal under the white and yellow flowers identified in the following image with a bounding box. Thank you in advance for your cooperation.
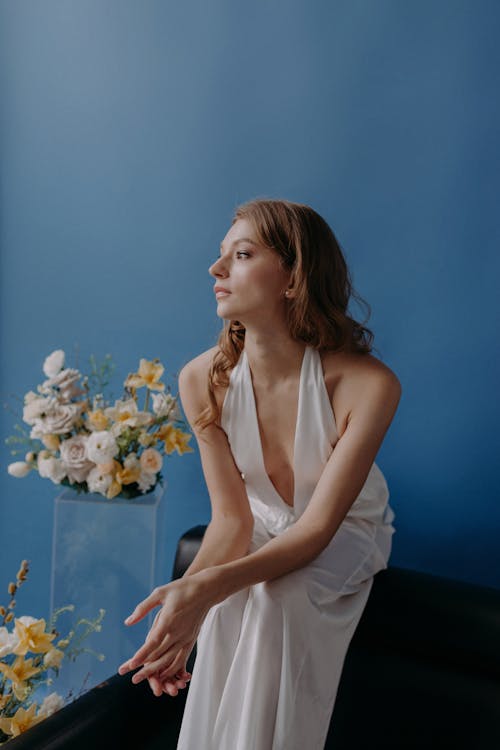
[50,485,168,697]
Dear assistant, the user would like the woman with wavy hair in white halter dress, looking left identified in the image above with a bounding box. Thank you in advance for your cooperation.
[119,200,401,750]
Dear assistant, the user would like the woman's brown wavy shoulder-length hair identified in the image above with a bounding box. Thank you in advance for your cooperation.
[195,198,373,429]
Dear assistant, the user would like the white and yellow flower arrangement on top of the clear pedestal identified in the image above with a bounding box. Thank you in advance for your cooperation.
[6,349,193,499]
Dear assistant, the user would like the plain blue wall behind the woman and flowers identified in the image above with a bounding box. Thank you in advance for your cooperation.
[0,0,500,628]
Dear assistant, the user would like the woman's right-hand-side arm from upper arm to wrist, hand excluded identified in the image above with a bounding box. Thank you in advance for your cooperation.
[196,371,401,603]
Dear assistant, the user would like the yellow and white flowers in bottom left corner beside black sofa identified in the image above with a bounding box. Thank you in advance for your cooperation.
[0,560,105,745]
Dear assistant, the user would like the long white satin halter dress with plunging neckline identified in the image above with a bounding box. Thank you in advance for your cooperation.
[177,347,395,750]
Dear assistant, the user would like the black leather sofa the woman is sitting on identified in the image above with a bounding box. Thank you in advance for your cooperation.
[7,526,500,750]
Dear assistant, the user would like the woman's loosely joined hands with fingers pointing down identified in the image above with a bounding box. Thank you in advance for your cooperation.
[118,573,215,695]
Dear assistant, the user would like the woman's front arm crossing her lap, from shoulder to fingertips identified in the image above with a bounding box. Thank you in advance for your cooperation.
[120,371,401,683]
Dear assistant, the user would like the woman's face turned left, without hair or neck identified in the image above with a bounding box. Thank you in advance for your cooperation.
[208,219,291,326]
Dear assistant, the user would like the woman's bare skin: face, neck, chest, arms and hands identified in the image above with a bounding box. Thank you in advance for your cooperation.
[119,219,401,695]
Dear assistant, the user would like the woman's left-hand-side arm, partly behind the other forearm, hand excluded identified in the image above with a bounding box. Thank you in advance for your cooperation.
[179,350,253,576]
